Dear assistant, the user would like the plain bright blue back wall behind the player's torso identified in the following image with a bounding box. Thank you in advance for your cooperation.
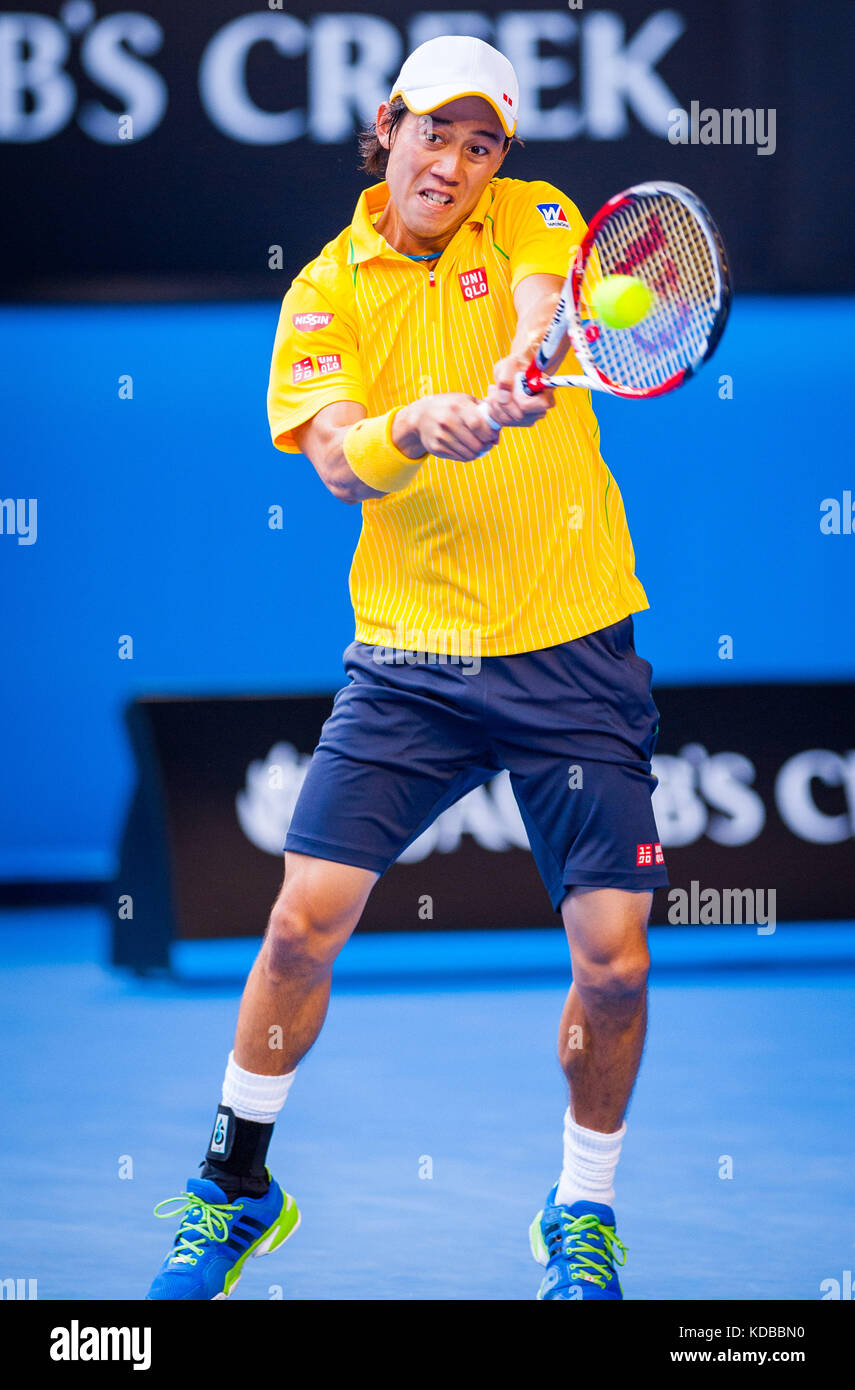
[0,299,855,878]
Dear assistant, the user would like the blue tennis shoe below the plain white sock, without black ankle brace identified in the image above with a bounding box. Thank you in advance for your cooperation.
[528,1183,627,1302]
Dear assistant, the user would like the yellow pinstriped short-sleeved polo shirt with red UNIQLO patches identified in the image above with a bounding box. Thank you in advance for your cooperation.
[268,178,648,656]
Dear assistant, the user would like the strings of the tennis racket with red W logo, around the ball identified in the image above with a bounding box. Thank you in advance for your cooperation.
[580,192,722,391]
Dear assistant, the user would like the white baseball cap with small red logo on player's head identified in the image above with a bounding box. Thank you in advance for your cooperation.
[389,33,520,136]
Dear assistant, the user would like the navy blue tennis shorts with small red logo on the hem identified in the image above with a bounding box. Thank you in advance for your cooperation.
[285,617,669,912]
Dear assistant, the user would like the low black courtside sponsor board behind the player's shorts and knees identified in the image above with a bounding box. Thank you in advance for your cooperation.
[110,684,855,966]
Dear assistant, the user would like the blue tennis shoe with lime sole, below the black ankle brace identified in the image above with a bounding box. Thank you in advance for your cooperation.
[146,1177,300,1302]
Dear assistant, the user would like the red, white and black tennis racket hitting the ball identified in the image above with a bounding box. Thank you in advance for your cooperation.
[481,183,731,430]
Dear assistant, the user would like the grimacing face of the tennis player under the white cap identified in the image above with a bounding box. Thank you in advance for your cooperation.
[377,96,505,253]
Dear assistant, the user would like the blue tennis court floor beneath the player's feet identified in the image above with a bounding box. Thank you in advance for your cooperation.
[0,908,855,1301]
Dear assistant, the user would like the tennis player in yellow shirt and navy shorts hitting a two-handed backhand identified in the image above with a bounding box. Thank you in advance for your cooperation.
[149,36,667,1300]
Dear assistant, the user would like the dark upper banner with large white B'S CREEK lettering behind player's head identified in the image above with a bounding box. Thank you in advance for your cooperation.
[0,0,855,299]
